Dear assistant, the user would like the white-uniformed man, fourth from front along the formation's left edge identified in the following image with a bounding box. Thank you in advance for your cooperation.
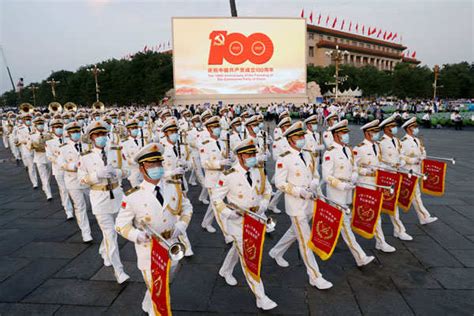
[45,119,74,219]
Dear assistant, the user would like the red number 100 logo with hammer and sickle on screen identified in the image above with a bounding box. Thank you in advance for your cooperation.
[208,31,273,65]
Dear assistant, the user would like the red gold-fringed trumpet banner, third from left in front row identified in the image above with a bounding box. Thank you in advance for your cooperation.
[308,200,344,260]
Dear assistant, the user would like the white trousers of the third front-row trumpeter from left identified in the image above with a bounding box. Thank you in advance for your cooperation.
[271,216,321,280]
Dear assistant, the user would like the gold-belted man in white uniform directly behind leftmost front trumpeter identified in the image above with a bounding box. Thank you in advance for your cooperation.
[77,121,129,284]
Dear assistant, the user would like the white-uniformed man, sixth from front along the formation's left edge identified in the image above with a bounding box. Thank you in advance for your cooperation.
[15,113,38,189]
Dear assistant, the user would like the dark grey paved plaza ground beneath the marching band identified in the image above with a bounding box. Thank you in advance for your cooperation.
[0,126,474,316]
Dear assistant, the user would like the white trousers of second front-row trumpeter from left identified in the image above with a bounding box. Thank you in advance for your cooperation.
[220,235,265,299]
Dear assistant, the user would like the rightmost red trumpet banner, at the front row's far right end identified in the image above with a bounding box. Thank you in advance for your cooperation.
[421,159,446,196]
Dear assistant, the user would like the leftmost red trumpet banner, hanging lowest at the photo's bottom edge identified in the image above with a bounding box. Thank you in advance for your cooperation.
[150,237,171,316]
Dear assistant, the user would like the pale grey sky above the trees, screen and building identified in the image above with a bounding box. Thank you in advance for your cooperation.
[0,0,474,93]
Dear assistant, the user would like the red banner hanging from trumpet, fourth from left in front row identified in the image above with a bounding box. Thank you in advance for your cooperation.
[351,187,382,239]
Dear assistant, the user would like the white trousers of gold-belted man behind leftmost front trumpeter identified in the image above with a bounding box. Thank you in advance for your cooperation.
[95,213,123,277]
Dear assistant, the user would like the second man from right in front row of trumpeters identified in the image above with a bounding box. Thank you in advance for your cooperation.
[379,115,413,241]
